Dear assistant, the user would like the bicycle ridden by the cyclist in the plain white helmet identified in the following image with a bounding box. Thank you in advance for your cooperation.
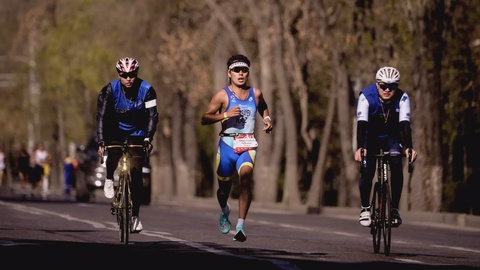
[361,149,413,256]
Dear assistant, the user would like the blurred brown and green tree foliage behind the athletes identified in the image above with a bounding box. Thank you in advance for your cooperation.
[0,0,480,214]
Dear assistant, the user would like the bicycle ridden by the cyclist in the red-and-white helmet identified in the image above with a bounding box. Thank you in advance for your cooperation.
[101,139,149,244]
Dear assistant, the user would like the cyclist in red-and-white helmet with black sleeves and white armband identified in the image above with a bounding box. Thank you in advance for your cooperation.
[97,57,158,233]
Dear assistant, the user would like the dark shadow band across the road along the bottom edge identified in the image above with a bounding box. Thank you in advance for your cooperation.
[0,238,478,270]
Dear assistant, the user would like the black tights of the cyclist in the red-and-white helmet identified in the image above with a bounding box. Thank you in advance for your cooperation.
[106,137,145,216]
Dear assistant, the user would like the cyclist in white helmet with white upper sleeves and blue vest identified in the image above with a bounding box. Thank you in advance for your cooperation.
[355,67,417,227]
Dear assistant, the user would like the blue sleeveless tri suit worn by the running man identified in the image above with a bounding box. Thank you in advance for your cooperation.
[216,86,257,181]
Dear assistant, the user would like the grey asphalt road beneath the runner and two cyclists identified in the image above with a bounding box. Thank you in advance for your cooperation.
[0,190,480,270]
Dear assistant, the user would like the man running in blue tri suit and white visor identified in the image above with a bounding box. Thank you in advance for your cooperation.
[201,55,273,242]
